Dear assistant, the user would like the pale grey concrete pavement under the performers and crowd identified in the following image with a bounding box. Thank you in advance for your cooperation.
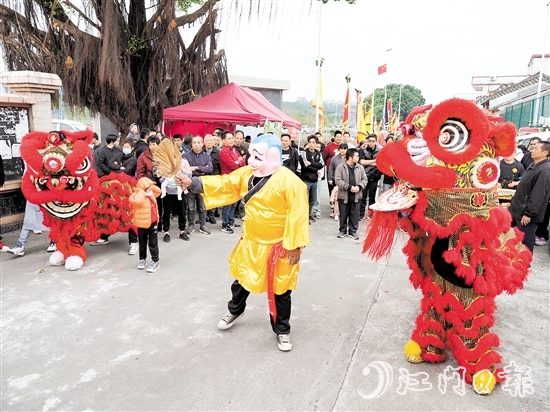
[0,195,550,411]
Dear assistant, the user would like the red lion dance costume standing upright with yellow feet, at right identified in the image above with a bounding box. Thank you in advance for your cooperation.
[364,99,532,394]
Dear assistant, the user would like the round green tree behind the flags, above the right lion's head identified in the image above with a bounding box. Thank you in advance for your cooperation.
[364,83,426,121]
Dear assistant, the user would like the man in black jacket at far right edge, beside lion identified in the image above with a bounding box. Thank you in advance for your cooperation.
[510,142,550,252]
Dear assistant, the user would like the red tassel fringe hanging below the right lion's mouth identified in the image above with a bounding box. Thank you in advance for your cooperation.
[363,210,398,260]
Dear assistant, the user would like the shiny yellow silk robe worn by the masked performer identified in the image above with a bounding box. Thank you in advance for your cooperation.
[201,166,309,295]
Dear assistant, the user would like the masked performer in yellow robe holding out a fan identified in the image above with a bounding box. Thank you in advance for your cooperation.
[176,134,309,351]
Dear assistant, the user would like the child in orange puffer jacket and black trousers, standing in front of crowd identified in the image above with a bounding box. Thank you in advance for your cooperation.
[130,177,160,273]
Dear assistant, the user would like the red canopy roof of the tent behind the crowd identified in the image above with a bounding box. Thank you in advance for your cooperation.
[162,83,302,129]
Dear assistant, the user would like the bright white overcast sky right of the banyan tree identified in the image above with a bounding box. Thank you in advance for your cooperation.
[218,0,550,103]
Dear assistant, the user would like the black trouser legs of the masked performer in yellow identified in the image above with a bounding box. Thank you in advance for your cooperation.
[227,280,292,335]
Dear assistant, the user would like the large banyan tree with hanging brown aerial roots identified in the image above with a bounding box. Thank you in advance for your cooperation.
[0,0,228,131]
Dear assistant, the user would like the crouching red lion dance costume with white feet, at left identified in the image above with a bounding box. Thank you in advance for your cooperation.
[21,130,135,270]
